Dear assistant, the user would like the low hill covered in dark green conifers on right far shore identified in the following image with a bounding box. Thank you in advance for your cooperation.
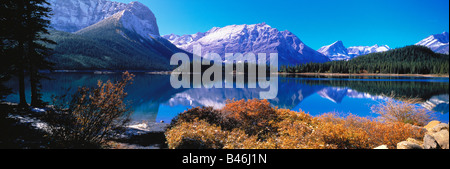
[280,46,449,74]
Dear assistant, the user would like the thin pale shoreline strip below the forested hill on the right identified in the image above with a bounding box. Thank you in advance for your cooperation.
[278,73,449,78]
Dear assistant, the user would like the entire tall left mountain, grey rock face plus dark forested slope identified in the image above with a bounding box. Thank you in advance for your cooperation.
[45,0,186,71]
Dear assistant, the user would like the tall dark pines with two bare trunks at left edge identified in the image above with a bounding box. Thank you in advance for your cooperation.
[2,0,54,107]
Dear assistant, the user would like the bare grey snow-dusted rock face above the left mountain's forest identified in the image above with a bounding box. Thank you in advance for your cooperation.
[49,0,159,36]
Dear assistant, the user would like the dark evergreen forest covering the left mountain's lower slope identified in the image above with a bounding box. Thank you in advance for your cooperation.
[48,26,177,70]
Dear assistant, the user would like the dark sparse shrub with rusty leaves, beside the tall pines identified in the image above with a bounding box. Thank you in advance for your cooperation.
[47,72,134,148]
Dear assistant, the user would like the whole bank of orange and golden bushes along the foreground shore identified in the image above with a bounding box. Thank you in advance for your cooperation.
[166,99,424,149]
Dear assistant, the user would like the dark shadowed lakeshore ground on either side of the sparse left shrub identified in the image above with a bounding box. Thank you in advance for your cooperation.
[0,103,169,149]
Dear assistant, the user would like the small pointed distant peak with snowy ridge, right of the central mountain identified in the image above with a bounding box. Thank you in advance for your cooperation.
[317,41,391,61]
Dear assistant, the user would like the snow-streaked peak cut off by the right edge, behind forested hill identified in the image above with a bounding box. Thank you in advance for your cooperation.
[416,32,449,54]
